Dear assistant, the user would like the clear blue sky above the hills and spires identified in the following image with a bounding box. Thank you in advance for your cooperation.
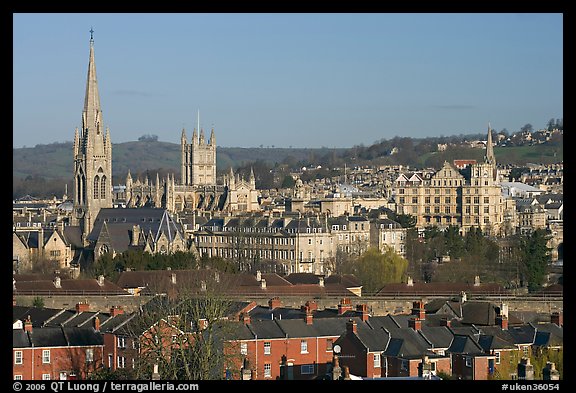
[13,13,564,148]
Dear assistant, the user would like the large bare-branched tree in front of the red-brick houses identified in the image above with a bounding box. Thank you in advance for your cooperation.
[127,270,239,380]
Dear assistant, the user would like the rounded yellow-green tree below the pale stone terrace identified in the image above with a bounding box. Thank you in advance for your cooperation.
[355,247,408,293]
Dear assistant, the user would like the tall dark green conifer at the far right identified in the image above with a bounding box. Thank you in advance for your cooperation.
[522,229,551,292]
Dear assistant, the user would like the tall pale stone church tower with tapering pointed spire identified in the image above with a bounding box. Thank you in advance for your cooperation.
[73,29,112,245]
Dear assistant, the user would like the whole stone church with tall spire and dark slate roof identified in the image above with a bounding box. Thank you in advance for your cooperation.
[70,31,188,258]
